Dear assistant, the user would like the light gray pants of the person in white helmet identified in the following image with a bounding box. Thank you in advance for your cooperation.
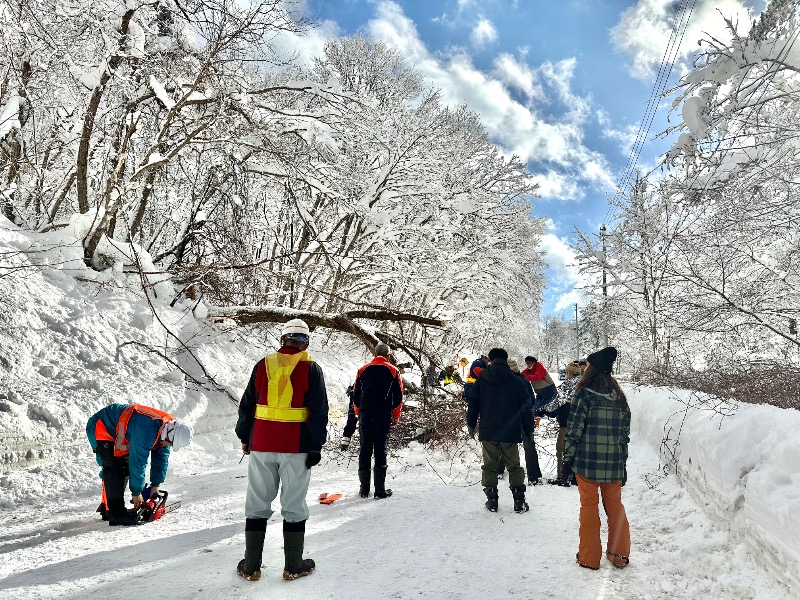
[244,452,311,523]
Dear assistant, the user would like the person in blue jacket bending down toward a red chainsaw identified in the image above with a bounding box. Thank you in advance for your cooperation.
[86,404,194,525]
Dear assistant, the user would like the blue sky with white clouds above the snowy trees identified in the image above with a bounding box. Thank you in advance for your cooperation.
[290,0,766,316]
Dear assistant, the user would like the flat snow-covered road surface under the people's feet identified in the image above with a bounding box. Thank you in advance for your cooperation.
[0,436,792,600]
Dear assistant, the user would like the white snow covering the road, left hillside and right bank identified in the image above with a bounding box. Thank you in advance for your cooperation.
[0,223,800,600]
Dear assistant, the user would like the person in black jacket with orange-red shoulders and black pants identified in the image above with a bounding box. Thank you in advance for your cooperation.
[353,343,403,498]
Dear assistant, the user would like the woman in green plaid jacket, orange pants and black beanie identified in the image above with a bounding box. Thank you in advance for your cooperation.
[564,347,631,569]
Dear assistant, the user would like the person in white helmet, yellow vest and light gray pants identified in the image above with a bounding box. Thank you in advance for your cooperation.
[236,319,328,581]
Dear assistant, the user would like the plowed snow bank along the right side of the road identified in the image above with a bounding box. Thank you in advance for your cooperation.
[628,388,800,589]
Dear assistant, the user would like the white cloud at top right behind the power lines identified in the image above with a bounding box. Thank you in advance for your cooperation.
[611,0,753,79]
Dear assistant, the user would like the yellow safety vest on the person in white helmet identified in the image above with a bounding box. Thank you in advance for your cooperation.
[255,352,314,423]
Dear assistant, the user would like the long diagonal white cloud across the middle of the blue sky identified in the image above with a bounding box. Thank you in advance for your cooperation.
[367,0,614,200]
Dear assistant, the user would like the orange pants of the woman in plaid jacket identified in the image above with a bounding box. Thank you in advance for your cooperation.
[577,475,631,569]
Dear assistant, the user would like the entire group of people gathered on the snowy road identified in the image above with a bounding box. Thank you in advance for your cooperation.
[87,319,631,581]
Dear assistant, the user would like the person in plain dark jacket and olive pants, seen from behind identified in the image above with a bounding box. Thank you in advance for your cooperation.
[467,348,533,513]
